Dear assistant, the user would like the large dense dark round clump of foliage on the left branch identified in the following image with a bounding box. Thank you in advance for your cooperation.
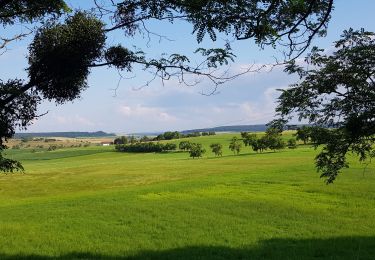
[28,12,106,103]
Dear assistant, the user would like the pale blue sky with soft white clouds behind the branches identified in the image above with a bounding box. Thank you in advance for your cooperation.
[0,0,375,134]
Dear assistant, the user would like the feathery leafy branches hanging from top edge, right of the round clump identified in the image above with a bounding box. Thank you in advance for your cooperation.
[114,0,333,57]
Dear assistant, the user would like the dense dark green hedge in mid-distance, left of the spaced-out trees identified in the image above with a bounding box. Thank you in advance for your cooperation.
[115,142,177,153]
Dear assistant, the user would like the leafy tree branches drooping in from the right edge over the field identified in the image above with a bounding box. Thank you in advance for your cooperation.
[276,29,375,183]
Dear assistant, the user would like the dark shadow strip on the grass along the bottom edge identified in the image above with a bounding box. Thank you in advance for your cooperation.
[0,237,375,260]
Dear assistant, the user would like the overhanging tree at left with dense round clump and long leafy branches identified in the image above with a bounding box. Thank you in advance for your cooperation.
[0,0,333,171]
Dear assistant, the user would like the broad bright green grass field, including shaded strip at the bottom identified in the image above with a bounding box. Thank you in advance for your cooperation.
[0,134,375,259]
